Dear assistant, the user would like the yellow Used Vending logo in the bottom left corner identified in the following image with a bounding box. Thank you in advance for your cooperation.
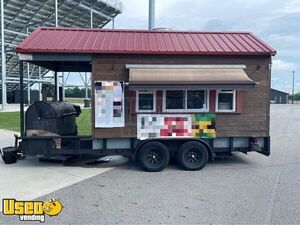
[2,199,63,223]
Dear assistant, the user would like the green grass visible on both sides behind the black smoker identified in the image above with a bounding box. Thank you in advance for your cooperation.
[0,109,92,135]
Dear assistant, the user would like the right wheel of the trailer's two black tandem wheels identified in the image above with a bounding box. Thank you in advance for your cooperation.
[177,141,208,170]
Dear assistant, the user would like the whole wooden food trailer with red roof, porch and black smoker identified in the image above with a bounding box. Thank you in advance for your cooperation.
[2,28,276,171]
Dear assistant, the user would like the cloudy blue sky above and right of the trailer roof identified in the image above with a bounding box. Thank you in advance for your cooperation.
[68,0,300,92]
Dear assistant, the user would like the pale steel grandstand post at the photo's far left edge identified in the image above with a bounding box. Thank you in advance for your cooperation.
[1,0,7,110]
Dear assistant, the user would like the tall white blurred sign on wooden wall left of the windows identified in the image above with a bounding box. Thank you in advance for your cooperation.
[95,81,125,128]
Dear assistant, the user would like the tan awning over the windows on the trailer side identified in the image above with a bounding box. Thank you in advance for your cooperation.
[129,68,255,89]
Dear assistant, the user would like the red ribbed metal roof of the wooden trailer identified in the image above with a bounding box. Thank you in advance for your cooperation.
[16,27,276,55]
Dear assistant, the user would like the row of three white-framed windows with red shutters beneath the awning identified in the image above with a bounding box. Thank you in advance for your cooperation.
[131,89,243,113]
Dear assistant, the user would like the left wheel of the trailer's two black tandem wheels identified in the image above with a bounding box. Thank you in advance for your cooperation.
[138,141,170,172]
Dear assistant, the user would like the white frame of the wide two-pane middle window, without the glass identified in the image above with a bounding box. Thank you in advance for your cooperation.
[162,88,210,113]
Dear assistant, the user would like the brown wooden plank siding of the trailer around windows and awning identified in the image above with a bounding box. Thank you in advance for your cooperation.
[92,55,271,138]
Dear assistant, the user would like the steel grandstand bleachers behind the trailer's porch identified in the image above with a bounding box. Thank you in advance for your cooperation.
[0,0,122,109]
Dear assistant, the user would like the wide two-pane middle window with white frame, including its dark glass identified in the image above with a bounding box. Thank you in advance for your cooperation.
[163,90,208,112]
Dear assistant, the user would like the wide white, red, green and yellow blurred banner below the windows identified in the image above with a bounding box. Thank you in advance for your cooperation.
[137,113,216,140]
